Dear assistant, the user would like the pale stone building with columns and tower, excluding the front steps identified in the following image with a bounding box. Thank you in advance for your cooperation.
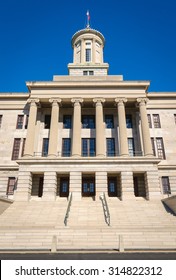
[0,26,176,201]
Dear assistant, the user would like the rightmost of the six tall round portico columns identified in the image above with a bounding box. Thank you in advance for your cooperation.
[137,98,153,156]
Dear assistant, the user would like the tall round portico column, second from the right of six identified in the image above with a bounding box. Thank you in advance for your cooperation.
[115,98,129,156]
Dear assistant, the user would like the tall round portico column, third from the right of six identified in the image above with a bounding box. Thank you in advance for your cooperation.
[93,98,106,157]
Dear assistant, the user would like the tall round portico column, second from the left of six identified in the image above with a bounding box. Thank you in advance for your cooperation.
[48,98,61,156]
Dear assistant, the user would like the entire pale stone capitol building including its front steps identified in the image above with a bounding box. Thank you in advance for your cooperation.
[0,21,176,251]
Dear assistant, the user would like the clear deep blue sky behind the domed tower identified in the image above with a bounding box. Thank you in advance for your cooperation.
[0,0,176,92]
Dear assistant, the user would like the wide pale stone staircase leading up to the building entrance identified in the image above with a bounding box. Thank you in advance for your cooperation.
[0,198,176,250]
